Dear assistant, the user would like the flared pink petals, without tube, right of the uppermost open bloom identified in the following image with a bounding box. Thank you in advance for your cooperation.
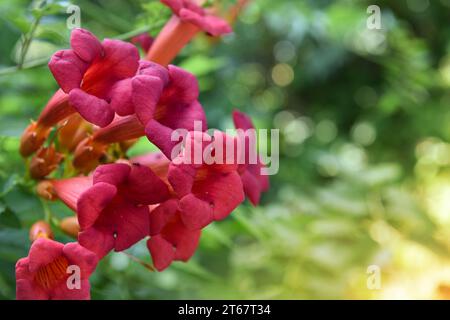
[132,62,207,158]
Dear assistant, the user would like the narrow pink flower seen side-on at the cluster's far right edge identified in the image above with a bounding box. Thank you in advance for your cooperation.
[233,110,269,206]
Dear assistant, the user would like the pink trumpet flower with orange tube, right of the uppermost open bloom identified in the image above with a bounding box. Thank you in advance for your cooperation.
[73,57,206,173]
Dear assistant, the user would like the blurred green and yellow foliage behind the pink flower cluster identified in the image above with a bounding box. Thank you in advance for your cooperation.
[0,0,450,299]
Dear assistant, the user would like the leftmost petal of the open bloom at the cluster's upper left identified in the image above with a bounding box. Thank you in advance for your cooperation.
[48,50,88,93]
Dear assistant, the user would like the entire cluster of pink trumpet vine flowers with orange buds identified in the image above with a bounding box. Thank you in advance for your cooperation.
[16,0,269,299]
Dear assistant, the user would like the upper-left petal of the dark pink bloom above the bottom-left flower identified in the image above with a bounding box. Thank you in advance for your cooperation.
[77,182,117,231]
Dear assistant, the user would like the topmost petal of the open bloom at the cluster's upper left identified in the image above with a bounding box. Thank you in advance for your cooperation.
[70,28,103,62]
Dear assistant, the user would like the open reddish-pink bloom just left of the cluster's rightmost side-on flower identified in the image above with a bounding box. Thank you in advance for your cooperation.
[168,131,245,229]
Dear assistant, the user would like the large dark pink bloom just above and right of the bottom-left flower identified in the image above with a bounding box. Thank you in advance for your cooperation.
[77,163,169,258]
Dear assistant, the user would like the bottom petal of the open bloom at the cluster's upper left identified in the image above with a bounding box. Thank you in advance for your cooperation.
[69,89,114,127]
